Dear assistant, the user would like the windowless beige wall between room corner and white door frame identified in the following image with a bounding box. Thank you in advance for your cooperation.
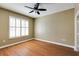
[35,9,74,46]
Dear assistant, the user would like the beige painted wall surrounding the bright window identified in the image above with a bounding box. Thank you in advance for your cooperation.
[0,8,34,46]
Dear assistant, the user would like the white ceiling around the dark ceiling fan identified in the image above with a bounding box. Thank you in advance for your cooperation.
[0,3,74,18]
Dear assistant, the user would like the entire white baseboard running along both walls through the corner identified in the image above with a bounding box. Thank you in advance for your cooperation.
[0,38,78,51]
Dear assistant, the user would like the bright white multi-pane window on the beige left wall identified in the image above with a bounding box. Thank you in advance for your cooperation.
[9,16,29,38]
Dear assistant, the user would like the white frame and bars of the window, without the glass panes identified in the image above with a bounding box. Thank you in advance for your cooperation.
[9,16,29,38]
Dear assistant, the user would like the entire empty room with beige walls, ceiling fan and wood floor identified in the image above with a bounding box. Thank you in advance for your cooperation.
[0,3,79,56]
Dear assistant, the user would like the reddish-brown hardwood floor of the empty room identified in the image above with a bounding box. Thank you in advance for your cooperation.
[0,40,77,56]
